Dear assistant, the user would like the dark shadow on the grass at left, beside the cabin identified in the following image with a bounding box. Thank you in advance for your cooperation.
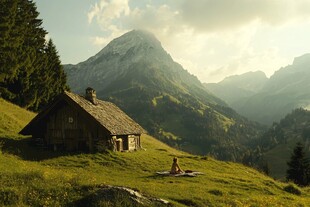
[0,136,85,161]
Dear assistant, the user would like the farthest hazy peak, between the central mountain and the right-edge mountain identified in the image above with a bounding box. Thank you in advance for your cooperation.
[204,71,268,106]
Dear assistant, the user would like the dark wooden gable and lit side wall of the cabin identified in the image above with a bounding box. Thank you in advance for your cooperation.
[42,101,141,151]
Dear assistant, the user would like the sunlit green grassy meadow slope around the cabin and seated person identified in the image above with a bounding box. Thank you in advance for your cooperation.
[0,99,310,207]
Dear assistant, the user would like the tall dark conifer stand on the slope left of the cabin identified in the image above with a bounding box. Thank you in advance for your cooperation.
[0,0,68,111]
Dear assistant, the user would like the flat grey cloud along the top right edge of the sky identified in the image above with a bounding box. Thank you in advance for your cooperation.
[178,0,310,32]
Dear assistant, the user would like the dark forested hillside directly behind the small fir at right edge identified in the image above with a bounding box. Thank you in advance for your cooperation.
[258,108,310,179]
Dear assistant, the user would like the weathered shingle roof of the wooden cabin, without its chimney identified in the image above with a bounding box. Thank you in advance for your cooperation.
[20,91,146,135]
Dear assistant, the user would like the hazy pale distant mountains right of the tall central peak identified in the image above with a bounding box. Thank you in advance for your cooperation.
[205,54,310,125]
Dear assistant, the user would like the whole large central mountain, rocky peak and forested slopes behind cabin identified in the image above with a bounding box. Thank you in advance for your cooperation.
[64,30,258,160]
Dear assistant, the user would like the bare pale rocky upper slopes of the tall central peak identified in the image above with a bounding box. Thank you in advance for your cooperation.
[66,30,212,101]
